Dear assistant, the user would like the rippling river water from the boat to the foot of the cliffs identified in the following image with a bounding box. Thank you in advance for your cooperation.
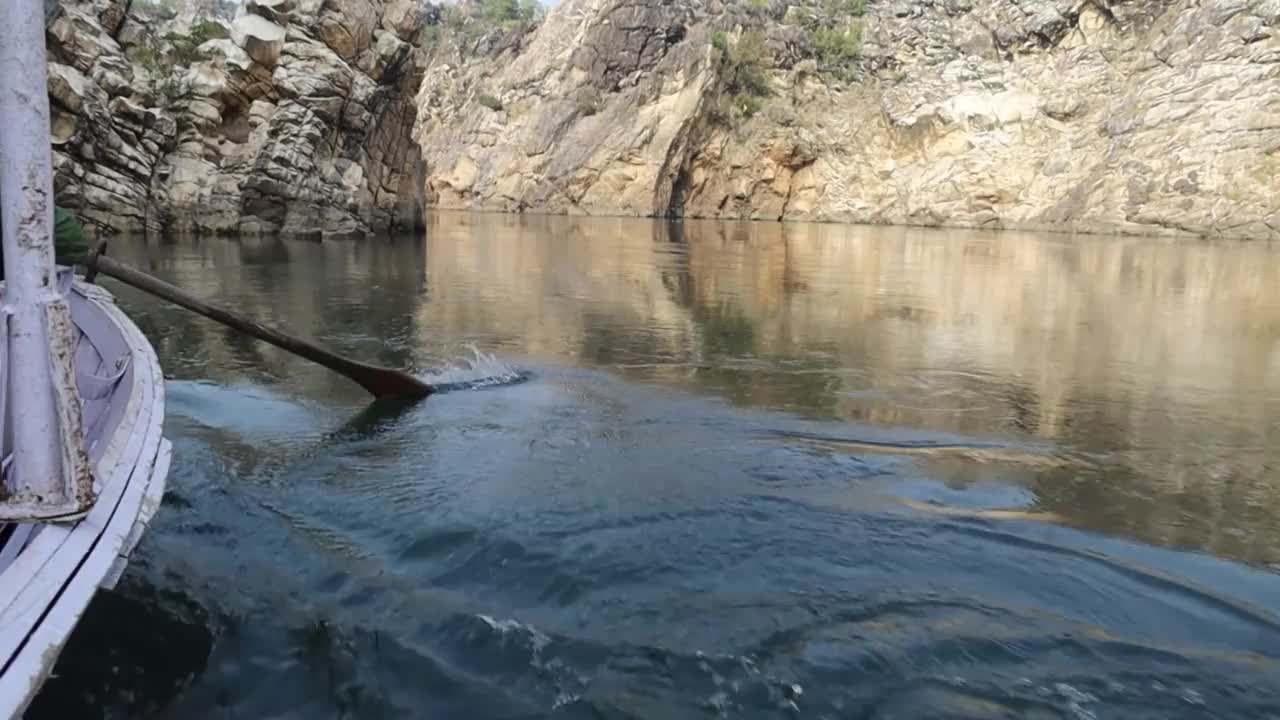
[32,214,1280,720]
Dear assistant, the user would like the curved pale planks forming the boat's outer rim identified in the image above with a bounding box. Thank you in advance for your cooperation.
[0,286,170,717]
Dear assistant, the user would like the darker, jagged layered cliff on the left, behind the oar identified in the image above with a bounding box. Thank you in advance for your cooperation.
[47,0,422,234]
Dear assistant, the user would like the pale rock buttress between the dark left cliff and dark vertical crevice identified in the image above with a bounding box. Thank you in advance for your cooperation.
[417,0,714,215]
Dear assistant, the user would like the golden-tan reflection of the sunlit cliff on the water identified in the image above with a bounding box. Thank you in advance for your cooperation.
[417,215,1280,562]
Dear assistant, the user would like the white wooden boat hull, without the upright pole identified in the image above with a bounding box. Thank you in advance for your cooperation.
[0,273,170,717]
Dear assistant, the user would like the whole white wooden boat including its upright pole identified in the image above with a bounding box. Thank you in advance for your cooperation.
[0,0,170,719]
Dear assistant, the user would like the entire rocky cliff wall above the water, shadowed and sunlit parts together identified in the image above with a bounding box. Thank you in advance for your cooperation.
[49,0,1280,237]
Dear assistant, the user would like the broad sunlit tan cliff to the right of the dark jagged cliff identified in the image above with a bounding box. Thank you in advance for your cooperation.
[415,0,1280,237]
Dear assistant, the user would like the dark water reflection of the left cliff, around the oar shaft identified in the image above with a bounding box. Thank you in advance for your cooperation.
[105,238,426,398]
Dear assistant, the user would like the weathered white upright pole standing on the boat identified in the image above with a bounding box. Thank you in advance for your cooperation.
[0,0,92,518]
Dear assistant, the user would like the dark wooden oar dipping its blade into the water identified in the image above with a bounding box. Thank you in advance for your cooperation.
[84,243,435,400]
